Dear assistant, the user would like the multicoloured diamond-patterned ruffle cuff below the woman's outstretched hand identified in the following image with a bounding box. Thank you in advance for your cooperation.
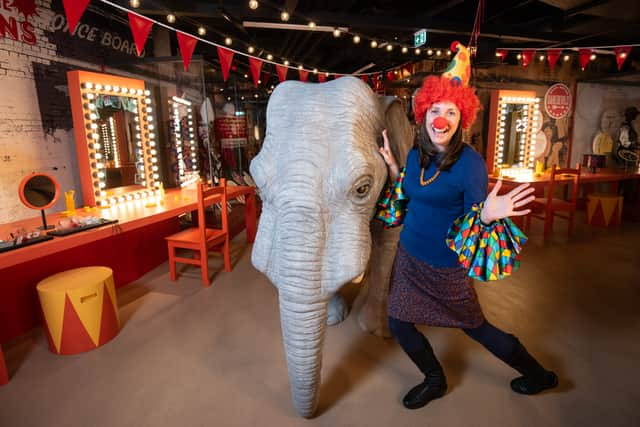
[447,203,527,282]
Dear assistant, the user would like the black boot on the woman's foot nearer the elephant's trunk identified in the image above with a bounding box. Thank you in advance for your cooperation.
[402,352,447,409]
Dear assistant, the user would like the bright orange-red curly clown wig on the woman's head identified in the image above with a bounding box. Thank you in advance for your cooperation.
[414,76,480,129]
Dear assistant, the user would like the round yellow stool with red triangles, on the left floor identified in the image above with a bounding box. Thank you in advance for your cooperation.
[36,267,120,354]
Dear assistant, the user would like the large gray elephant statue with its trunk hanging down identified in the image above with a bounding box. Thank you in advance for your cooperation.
[250,77,413,418]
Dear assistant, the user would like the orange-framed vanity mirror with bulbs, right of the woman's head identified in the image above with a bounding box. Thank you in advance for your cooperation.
[487,90,542,178]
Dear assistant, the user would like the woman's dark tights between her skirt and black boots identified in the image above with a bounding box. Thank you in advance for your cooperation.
[389,317,520,364]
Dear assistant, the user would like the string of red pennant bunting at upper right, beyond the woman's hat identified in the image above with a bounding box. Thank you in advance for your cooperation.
[496,44,640,71]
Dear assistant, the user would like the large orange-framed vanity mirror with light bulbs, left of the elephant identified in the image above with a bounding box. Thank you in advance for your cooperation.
[67,71,161,207]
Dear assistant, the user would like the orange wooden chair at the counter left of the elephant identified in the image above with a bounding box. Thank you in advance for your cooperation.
[166,179,231,286]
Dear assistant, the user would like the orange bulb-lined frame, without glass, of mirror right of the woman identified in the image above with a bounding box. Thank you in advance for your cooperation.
[487,90,542,175]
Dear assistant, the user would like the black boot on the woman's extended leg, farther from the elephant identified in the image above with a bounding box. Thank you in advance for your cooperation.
[509,342,558,394]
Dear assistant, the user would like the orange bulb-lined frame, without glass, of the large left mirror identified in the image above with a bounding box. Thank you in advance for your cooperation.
[67,71,160,207]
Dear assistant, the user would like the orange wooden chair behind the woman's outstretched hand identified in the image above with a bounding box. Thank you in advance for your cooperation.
[526,162,580,240]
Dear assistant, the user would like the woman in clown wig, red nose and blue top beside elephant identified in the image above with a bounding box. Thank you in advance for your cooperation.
[379,44,558,409]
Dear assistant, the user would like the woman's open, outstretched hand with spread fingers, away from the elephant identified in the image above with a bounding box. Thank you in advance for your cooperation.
[480,181,535,224]
